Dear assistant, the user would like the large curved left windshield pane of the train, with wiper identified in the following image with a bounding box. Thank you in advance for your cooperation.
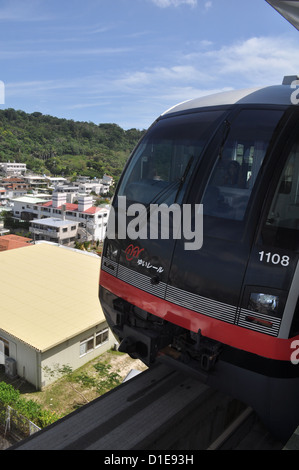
[118,111,223,204]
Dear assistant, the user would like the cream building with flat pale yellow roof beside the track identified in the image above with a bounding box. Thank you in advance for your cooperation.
[0,242,115,390]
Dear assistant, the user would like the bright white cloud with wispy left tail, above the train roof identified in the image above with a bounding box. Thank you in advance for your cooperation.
[113,37,299,93]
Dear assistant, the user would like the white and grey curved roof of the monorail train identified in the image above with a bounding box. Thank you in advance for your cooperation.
[162,76,299,116]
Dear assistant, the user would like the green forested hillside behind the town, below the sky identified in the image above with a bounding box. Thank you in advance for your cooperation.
[0,108,145,182]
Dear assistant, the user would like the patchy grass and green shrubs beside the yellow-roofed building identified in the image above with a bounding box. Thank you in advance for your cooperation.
[0,351,122,428]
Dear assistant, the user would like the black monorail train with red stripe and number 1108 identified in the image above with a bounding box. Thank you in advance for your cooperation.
[99,77,299,438]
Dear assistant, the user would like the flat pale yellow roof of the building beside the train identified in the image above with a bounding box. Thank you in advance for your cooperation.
[0,243,105,351]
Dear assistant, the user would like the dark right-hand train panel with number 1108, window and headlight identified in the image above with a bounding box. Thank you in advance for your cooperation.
[241,113,299,348]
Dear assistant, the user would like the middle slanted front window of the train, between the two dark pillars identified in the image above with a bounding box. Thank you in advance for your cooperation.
[202,109,281,221]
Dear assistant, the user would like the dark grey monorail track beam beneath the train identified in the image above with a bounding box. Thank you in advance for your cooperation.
[10,363,286,451]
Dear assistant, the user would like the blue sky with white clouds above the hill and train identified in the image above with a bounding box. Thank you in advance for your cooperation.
[0,0,299,129]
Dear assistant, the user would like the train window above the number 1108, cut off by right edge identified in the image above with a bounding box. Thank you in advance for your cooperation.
[262,142,299,250]
